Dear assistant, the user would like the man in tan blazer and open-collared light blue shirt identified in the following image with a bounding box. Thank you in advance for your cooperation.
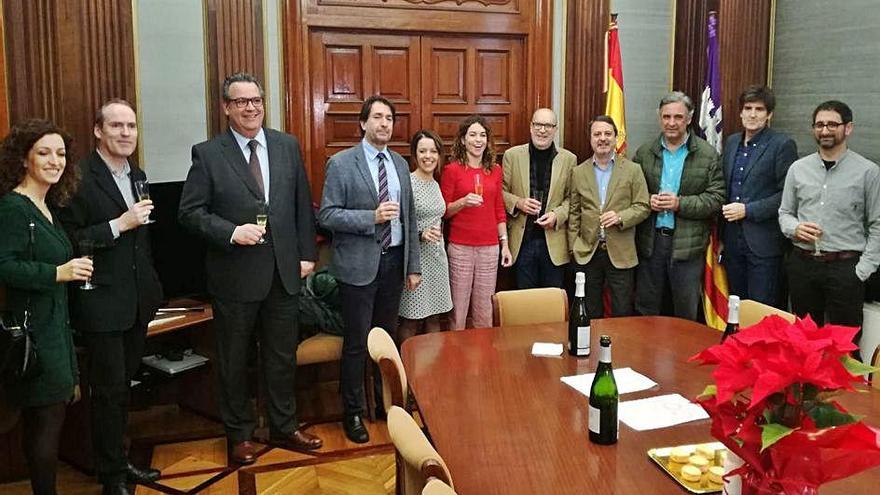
[568,115,650,318]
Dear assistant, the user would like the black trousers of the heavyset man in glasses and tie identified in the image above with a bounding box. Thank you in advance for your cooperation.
[214,269,299,443]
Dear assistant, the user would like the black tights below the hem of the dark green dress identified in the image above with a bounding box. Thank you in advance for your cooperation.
[22,402,67,495]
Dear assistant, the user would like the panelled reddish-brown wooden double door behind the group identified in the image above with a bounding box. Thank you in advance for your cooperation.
[308,30,529,198]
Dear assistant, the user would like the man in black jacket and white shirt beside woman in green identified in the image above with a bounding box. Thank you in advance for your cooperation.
[59,99,162,495]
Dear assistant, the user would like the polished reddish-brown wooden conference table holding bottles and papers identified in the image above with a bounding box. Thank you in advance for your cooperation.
[403,317,880,495]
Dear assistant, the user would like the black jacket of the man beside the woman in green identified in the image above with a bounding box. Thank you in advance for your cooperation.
[59,151,162,332]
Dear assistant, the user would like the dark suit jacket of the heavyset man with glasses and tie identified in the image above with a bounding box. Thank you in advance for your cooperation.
[178,128,318,302]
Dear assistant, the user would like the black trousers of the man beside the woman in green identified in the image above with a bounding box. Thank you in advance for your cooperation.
[84,324,147,484]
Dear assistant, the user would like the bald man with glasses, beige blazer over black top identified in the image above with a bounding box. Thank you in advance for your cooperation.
[502,108,577,289]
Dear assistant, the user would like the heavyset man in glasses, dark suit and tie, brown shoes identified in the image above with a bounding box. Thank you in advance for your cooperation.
[179,73,322,464]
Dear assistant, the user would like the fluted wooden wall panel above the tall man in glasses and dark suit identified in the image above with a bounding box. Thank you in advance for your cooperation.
[205,0,266,135]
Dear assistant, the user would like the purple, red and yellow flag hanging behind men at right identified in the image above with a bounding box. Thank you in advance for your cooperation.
[700,12,728,330]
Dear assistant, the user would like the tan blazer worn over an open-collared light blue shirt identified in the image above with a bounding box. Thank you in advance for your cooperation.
[568,156,651,269]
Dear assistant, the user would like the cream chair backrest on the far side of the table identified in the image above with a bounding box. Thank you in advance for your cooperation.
[492,287,568,326]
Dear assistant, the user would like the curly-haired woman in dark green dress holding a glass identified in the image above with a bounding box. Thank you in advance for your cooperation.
[0,119,92,495]
